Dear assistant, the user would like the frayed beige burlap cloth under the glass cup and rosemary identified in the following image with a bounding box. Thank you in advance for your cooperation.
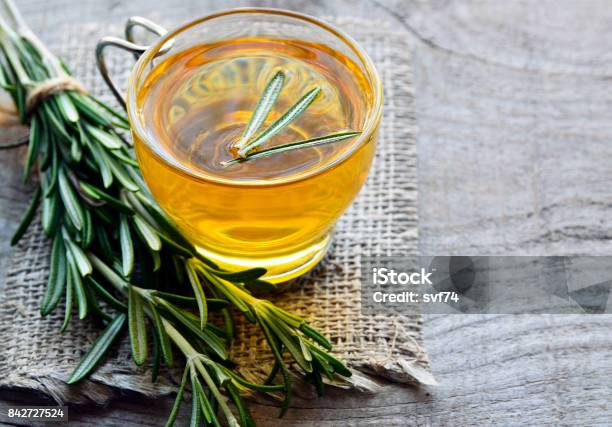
[0,19,434,403]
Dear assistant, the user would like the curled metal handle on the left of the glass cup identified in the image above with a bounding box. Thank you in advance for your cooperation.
[96,16,172,108]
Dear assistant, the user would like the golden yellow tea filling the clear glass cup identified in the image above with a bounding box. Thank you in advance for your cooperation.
[134,38,375,282]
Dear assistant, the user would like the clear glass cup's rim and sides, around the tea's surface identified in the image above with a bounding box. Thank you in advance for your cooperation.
[127,9,382,283]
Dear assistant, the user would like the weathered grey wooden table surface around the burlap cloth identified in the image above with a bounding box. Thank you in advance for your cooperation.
[0,0,612,427]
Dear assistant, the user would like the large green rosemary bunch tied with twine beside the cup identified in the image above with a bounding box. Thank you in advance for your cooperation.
[0,0,351,425]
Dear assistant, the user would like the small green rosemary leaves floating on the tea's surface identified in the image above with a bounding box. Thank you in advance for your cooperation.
[222,71,361,166]
